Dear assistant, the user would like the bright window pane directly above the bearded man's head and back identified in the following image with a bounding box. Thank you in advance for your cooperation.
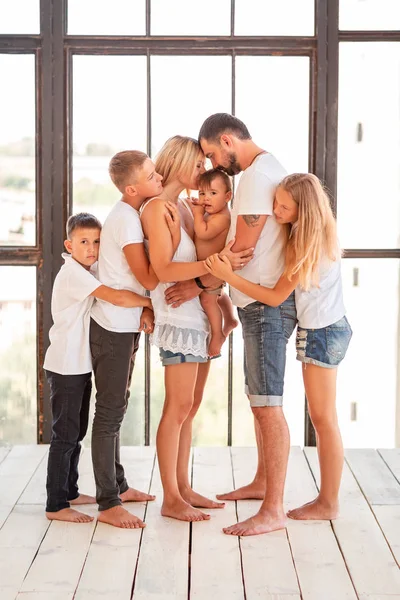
[236,56,310,172]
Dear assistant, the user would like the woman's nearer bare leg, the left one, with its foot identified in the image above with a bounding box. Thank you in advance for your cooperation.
[157,363,209,521]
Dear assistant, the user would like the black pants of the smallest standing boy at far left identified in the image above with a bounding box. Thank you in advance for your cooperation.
[46,371,92,512]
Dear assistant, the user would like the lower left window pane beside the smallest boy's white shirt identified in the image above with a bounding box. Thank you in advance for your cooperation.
[0,267,37,444]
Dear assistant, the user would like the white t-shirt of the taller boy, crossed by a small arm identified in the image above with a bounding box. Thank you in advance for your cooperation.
[92,200,145,333]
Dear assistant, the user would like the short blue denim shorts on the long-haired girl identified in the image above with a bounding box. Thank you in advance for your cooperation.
[296,317,353,369]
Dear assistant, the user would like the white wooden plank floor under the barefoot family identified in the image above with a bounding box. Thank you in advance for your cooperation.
[0,446,400,600]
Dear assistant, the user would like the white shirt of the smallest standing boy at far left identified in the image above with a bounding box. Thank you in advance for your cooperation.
[43,253,101,375]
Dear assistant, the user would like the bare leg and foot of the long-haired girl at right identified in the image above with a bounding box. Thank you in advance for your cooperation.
[288,363,343,519]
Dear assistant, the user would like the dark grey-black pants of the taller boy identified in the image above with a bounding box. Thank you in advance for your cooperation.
[90,319,140,510]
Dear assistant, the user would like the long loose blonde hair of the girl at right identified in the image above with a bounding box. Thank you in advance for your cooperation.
[279,173,340,290]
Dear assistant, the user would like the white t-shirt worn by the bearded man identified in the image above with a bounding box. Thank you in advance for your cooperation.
[227,153,287,308]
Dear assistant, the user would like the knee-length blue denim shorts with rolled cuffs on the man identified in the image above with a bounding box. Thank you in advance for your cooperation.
[238,293,297,406]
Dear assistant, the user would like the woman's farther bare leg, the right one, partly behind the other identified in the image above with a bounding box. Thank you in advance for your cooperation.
[177,361,225,508]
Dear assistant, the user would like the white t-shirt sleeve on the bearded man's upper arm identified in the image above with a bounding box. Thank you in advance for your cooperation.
[238,170,276,215]
